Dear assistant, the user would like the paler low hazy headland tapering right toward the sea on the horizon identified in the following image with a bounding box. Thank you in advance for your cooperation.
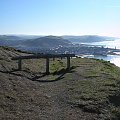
[62,35,115,43]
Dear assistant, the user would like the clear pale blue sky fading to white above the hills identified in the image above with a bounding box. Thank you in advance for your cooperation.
[0,0,120,37]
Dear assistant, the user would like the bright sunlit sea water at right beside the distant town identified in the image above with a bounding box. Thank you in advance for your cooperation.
[83,39,120,67]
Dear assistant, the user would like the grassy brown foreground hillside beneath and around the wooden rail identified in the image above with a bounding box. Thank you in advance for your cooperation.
[0,47,120,120]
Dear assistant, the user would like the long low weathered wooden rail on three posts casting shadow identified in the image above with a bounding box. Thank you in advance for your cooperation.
[12,54,75,74]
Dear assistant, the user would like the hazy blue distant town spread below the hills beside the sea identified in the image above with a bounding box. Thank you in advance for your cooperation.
[24,44,120,56]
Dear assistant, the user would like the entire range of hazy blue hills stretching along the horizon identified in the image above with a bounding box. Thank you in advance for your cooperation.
[0,35,115,52]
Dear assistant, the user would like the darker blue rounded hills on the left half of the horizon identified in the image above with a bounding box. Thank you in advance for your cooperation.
[0,35,71,49]
